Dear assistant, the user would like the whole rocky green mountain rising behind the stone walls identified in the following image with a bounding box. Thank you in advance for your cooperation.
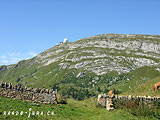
[0,34,160,100]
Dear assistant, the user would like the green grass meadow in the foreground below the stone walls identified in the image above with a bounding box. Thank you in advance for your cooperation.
[0,97,156,120]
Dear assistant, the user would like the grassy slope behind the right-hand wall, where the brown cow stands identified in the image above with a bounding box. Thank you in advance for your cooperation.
[110,67,160,96]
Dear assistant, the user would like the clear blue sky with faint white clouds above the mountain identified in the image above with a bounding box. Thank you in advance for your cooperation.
[0,0,160,65]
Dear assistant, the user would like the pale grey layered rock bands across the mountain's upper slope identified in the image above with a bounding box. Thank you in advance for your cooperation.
[37,34,160,75]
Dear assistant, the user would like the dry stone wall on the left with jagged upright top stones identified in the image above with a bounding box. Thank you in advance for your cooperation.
[0,82,57,104]
